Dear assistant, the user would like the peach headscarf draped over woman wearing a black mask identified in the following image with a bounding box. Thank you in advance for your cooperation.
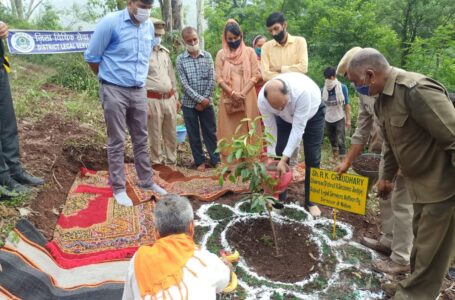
[221,19,251,84]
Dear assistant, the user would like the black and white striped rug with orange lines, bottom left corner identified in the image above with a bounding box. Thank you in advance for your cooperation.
[0,220,124,300]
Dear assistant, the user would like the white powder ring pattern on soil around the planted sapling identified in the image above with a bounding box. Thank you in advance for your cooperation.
[196,201,384,299]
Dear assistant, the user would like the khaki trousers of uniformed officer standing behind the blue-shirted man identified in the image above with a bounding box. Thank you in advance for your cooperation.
[148,96,177,165]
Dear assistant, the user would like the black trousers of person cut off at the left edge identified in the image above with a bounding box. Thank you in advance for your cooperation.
[0,67,21,181]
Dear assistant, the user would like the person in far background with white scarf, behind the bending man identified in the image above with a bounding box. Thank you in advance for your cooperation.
[322,67,351,161]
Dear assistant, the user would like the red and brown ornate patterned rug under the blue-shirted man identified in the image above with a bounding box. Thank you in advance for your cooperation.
[46,164,304,268]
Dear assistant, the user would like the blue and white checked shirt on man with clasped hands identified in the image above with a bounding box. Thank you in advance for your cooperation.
[176,50,215,108]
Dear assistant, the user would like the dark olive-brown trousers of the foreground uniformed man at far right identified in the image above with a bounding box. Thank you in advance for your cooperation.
[394,196,455,300]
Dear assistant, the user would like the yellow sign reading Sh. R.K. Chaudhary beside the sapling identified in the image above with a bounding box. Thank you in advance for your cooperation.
[310,168,368,215]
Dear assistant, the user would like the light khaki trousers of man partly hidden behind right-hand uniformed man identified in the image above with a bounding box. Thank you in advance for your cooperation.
[379,172,414,265]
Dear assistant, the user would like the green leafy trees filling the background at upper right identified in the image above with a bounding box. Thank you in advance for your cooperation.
[208,0,455,90]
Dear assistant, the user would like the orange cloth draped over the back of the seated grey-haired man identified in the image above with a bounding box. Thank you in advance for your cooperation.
[134,233,196,297]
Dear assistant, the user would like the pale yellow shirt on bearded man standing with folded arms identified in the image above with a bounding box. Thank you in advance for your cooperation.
[261,33,308,81]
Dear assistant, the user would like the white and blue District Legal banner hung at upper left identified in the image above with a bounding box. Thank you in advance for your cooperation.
[8,29,93,54]
